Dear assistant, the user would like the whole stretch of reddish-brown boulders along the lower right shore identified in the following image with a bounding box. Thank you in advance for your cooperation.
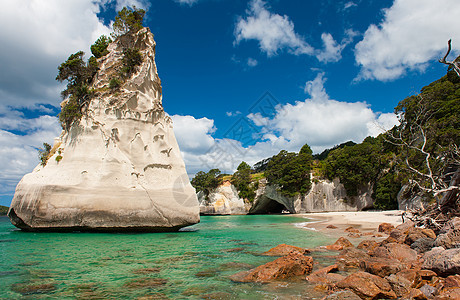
[230,214,460,300]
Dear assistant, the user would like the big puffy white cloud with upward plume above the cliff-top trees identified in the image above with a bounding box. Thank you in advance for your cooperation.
[250,73,396,152]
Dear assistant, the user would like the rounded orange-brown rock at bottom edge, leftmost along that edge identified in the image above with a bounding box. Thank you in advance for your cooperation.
[337,272,396,299]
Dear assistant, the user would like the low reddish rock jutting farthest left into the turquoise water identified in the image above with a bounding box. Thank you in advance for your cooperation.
[230,253,313,282]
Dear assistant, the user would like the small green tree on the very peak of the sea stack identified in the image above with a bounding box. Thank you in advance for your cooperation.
[112,6,145,37]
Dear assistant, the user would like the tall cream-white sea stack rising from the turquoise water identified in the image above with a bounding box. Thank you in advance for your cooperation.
[8,28,200,232]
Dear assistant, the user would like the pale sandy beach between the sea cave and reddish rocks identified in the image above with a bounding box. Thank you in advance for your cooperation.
[297,210,403,244]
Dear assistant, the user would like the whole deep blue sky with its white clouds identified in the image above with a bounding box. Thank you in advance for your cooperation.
[0,0,460,205]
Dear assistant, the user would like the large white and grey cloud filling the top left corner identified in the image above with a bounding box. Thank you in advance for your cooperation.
[0,0,110,106]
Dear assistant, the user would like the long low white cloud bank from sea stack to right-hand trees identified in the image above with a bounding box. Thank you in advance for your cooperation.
[173,73,398,174]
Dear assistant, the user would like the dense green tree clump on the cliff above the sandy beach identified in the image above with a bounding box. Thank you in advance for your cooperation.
[323,137,383,196]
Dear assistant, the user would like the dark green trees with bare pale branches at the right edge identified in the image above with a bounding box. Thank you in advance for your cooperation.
[388,71,460,197]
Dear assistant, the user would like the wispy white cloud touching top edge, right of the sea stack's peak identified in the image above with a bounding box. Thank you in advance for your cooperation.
[234,0,314,56]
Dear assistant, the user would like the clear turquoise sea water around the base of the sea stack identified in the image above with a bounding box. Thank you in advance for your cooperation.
[0,215,333,299]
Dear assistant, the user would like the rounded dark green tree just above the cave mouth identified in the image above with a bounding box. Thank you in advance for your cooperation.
[265,145,312,197]
